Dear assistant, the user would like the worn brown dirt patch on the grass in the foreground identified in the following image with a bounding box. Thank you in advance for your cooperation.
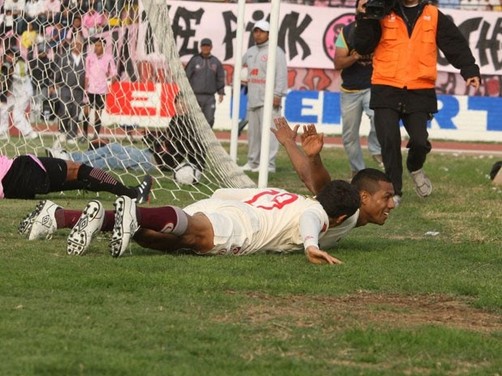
[225,292,502,333]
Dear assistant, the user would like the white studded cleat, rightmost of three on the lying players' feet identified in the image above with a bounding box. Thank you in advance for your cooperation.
[110,196,139,257]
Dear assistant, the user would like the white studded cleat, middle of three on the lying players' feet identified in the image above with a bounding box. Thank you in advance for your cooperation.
[66,200,105,256]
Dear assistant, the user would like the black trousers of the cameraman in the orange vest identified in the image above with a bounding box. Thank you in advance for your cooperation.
[374,108,431,196]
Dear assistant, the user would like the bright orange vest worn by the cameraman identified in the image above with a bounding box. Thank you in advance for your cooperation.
[371,5,438,90]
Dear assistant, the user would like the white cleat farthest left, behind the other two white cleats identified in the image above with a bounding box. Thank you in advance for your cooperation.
[18,200,61,240]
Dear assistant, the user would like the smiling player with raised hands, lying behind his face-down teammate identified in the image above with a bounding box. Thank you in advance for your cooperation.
[272,117,396,227]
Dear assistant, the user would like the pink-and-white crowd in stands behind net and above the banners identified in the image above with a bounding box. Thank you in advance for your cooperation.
[0,0,502,139]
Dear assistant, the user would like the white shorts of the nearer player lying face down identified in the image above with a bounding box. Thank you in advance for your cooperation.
[183,198,260,255]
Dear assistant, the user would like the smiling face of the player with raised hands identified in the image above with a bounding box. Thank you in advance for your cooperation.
[361,181,395,225]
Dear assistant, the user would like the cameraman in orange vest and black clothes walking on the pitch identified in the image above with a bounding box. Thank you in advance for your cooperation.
[354,0,480,203]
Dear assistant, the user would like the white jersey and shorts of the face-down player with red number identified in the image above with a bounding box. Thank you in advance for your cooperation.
[184,188,329,255]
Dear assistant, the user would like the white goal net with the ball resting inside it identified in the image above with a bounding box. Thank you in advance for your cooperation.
[0,0,255,200]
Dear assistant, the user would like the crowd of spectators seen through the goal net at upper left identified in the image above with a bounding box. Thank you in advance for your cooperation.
[0,0,138,131]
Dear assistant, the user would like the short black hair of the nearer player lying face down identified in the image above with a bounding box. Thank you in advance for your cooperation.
[316,180,361,218]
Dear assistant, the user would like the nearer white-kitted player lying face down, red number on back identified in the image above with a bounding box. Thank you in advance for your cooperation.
[20,180,360,264]
